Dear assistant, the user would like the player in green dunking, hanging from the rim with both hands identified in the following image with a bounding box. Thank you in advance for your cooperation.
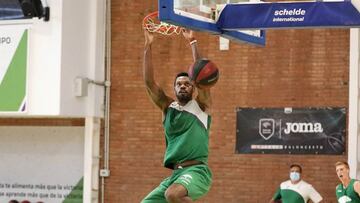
[142,30,212,203]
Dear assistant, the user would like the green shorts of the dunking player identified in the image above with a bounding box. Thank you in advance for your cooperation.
[141,164,212,203]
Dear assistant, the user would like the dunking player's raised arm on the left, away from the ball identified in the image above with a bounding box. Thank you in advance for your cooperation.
[143,30,173,112]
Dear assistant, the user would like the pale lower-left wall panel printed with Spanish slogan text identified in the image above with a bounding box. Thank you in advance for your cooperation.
[0,126,85,203]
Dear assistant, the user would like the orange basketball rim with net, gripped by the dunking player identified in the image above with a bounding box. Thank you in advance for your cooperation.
[143,11,181,35]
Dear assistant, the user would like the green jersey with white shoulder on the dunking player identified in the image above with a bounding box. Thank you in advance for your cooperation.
[163,100,211,169]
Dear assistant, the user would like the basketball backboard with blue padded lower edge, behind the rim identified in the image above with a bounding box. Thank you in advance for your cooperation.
[159,0,265,46]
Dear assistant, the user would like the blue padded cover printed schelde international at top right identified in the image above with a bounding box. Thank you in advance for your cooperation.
[216,1,360,30]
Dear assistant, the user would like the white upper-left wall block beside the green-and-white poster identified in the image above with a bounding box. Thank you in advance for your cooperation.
[0,0,105,117]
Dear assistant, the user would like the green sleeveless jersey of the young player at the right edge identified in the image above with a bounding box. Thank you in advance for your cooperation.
[336,179,360,203]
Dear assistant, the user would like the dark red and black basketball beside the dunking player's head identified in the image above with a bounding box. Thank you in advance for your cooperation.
[188,58,219,88]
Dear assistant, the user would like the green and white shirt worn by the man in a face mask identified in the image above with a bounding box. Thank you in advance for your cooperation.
[273,180,322,203]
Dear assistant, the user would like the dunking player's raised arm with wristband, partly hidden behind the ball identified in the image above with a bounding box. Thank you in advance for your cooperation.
[183,29,212,112]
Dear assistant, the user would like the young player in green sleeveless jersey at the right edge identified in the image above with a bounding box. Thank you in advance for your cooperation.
[335,161,360,203]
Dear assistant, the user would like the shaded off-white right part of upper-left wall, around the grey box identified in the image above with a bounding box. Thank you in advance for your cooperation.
[60,0,105,117]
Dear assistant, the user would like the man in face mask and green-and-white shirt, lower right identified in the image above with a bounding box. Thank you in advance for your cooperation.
[270,164,322,203]
